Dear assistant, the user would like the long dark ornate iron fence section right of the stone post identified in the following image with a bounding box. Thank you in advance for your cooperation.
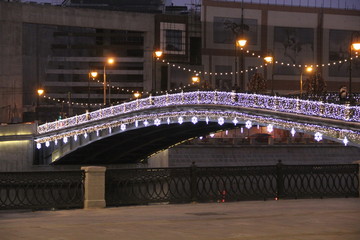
[105,163,359,206]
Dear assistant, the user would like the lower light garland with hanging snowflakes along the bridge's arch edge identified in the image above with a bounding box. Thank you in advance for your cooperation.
[35,110,360,149]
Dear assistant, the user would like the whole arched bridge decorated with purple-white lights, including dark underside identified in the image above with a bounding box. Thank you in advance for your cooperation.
[35,91,360,164]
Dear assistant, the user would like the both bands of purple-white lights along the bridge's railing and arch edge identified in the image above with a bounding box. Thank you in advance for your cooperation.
[35,91,360,152]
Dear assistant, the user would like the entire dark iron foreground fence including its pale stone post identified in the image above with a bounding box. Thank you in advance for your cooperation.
[0,163,360,210]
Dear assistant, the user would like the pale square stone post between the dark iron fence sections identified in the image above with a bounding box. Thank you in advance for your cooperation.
[81,167,106,209]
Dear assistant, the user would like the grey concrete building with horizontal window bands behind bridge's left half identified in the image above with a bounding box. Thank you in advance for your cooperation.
[0,1,201,123]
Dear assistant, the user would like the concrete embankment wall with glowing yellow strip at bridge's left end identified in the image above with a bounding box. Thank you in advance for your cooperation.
[0,124,36,172]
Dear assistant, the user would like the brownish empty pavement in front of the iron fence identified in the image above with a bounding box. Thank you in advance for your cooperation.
[0,198,360,240]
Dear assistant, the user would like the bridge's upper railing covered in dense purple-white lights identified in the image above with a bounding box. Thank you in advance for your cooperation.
[38,91,360,134]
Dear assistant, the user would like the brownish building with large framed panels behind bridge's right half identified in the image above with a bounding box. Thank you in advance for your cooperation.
[201,0,360,93]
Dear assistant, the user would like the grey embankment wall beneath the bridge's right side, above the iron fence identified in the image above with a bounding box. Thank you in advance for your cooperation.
[168,145,360,167]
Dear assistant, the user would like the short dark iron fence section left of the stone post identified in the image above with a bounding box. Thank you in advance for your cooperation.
[0,171,84,210]
